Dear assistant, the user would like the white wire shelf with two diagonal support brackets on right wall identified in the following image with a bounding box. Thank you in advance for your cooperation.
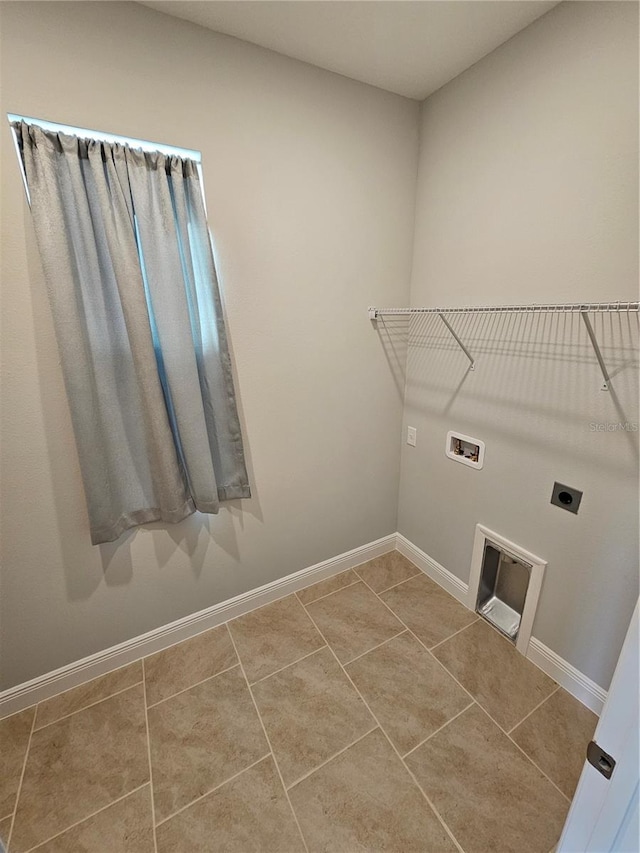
[368,302,640,391]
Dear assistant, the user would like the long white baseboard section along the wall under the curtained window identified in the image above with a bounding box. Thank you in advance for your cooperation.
[0,533,396,718]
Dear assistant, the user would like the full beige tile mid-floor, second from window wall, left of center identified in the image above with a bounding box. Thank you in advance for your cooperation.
[253,648,376,786]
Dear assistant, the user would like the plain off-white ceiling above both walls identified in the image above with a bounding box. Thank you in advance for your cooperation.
[139,0,558,100]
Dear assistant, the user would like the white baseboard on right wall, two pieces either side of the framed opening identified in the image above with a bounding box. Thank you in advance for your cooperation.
[396,533,607,715]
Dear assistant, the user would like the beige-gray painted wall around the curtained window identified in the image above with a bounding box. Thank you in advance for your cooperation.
[0,2,419,688]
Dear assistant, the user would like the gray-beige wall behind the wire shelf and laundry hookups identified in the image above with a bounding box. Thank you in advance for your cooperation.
[399,2,638,688]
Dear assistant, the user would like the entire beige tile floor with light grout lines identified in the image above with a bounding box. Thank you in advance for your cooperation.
[0,551,596,853]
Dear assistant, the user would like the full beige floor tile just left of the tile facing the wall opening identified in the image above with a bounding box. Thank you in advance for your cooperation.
[346,633,471,755]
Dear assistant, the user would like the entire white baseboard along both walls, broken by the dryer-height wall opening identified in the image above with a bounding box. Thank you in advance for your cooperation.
[0,533,607,718]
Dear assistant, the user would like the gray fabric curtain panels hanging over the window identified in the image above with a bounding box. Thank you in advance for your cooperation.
[14,122,250,544]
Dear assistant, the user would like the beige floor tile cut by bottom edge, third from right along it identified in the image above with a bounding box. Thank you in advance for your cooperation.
[157,756,304,853]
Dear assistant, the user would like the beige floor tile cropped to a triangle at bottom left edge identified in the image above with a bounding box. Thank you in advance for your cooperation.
[34,785,154,853]
